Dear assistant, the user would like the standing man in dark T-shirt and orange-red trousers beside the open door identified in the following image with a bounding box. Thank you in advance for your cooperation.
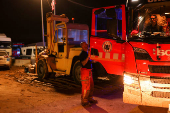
[80,42,97,106]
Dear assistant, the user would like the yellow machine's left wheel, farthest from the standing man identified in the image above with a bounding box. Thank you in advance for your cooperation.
[37,60,48,80]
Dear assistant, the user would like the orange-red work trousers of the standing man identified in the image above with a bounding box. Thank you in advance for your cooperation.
[81,68,94,102]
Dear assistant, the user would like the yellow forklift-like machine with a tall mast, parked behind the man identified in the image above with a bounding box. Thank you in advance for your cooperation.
[37,14,89,83]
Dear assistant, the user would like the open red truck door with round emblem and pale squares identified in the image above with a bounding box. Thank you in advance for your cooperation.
[90,5,126,75]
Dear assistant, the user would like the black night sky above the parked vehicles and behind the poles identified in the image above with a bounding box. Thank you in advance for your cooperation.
[0,0,125,44]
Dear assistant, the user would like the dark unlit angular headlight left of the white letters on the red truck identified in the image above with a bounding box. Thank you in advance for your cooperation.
[133,47,152,60]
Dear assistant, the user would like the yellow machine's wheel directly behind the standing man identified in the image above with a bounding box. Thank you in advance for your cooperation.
[72,60,82,84]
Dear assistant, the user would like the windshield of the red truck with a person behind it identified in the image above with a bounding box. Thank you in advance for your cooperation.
[128,2,170,38]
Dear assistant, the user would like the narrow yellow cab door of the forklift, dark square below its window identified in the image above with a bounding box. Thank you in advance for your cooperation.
[54,23,67,71]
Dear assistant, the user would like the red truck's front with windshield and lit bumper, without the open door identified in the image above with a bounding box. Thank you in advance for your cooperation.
[123,0,170,108]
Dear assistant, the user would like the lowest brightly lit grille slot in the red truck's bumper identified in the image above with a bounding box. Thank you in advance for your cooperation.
[151,91,170,98]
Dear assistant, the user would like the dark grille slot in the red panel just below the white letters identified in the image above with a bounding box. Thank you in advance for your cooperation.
[149,65,170,74]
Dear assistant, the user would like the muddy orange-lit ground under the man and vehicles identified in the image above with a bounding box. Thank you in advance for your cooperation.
[0,67,167,113]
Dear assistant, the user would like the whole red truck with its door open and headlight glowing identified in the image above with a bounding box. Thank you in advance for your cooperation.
[90,0,170,108]
